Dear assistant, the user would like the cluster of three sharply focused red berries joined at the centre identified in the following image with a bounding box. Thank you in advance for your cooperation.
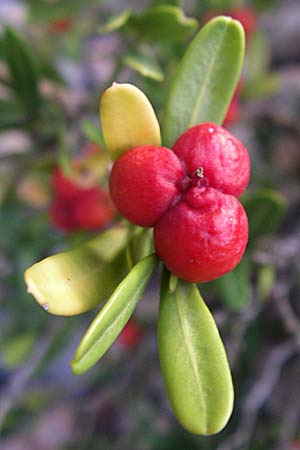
[110,123,250,282]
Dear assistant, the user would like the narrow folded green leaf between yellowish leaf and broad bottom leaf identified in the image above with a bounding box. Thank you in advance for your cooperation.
[71,255,158,374]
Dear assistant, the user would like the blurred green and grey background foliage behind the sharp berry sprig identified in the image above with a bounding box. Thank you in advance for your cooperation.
[0,0,300,450]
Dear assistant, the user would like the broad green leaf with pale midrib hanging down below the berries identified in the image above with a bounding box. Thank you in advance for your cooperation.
[158,271,234,435]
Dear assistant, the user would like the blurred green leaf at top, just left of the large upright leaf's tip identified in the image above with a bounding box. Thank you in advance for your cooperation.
[129,5,198,42]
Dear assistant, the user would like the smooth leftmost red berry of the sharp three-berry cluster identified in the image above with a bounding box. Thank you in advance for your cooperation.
[109,146,184,227]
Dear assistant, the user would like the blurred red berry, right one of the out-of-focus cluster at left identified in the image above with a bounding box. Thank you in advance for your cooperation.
[73,188,115,231]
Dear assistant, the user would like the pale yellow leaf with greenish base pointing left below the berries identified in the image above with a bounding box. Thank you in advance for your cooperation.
[25,226,128,316]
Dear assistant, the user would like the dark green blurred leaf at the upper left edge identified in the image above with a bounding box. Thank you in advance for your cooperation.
[3,28,40,115]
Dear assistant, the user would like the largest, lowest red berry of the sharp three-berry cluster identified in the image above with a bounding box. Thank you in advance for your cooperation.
[154,187,248,282]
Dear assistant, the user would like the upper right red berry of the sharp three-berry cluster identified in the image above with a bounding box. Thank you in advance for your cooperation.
[173,123,250,197]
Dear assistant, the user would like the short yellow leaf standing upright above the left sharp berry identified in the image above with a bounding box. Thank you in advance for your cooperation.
[100,83,161,160]
